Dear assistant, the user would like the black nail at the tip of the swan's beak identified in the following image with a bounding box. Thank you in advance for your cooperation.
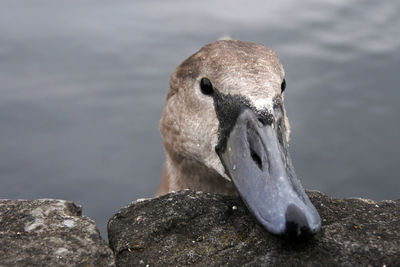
[285,204,313,239]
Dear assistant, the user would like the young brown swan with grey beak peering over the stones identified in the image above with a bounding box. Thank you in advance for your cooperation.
[158,40,321,238]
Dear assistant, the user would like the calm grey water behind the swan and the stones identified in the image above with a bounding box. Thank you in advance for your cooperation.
[0,0,400,239]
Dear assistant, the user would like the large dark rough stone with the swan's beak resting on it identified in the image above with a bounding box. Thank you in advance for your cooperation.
[108,191,400,266]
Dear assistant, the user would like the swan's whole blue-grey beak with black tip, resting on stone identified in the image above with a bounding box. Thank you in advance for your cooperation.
[218,108,321,237]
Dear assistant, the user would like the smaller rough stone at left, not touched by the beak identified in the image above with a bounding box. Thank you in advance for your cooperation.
[0,199,115,266]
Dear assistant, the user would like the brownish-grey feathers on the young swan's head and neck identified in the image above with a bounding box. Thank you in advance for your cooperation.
[158,40,289,194]
